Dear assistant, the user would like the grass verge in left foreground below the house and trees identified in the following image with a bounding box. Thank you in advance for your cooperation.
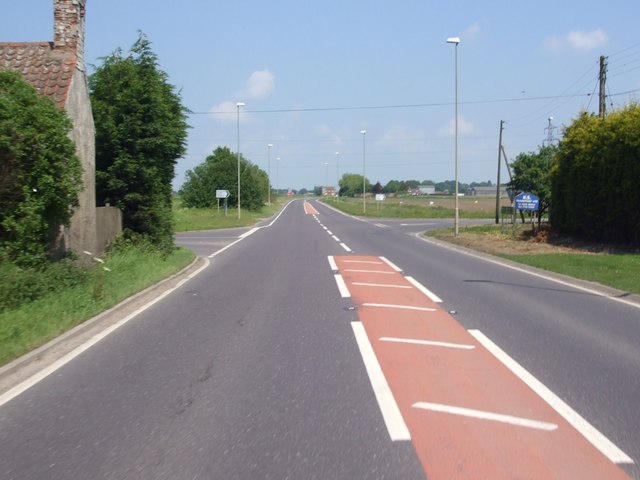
[0,247,195,365]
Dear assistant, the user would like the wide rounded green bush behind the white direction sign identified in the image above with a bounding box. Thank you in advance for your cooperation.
[180,147,269,211]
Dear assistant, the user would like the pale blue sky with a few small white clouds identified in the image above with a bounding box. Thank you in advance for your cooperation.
[5,0,640,189]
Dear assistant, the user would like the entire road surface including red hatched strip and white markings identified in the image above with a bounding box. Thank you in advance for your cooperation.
[0,200,640,479]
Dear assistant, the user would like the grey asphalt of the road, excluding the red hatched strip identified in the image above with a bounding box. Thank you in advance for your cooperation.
[0,201,640,479]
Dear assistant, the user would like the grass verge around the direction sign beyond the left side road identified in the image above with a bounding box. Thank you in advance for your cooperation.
[173,198,287,232]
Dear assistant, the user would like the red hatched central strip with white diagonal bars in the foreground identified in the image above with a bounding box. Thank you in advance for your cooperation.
[333,256,629,479]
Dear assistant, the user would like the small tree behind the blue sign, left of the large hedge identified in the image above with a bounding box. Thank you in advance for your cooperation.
[509,145,558,226]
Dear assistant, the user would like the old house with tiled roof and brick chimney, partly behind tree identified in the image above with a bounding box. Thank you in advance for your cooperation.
[0,0,100,253]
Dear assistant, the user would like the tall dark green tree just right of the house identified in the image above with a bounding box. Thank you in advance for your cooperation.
[89,32,188,251]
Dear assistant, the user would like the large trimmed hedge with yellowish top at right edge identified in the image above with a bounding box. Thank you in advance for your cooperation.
[551,104,640,245]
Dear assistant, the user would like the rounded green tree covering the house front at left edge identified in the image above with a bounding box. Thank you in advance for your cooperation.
[0,70,82,265]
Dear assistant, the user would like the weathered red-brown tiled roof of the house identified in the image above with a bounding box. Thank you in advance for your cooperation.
[0,42,76,108]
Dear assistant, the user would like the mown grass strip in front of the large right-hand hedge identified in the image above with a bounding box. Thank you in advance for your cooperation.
[500,253,640,294]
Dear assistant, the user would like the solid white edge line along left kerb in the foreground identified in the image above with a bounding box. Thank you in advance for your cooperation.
[0,258,210,407]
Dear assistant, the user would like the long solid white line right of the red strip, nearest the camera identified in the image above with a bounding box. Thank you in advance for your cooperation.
[469,330,634,463]
